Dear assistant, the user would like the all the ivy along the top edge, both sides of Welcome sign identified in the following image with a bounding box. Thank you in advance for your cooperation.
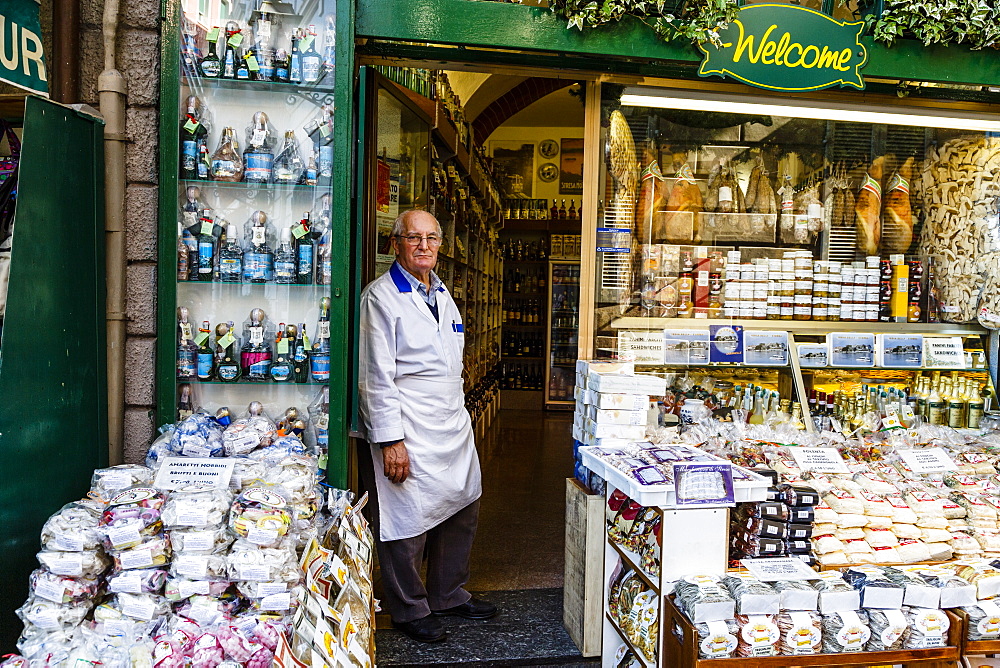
[548,0,1000,49]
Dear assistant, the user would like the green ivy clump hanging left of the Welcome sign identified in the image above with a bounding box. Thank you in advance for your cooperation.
[549,0,739,43]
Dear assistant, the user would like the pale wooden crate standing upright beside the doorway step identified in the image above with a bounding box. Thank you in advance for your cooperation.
[563,478,605,656]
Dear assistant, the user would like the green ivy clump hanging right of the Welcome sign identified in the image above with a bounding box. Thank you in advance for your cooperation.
[867,0,1000,49]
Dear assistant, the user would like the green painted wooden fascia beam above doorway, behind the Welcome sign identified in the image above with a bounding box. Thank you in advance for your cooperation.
[355,0,1000,86]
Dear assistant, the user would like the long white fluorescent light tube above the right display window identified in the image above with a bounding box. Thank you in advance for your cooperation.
[621,88,1000,132]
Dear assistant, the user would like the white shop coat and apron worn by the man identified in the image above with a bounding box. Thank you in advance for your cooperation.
[358,263,482,541]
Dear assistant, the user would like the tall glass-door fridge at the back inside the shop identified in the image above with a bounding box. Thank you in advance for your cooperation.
[545,260,580,410]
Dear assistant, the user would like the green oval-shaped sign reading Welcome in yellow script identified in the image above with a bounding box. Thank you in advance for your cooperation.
[698,4,868,91]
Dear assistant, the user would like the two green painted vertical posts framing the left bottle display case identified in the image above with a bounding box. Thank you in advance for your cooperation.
[156,0,360,487]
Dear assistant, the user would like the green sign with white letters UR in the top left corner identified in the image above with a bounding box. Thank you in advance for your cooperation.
[0,0,49,97]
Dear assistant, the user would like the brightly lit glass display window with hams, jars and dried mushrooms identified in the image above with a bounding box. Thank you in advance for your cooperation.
[580,86,1000,431]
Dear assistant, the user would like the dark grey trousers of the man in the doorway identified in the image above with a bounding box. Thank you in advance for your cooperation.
[358,442,479,623]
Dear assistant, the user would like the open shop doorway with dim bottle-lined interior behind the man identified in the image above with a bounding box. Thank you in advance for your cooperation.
[358,63,588,665]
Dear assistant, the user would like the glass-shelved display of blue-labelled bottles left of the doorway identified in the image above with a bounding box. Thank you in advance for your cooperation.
[169,3,334,452]
